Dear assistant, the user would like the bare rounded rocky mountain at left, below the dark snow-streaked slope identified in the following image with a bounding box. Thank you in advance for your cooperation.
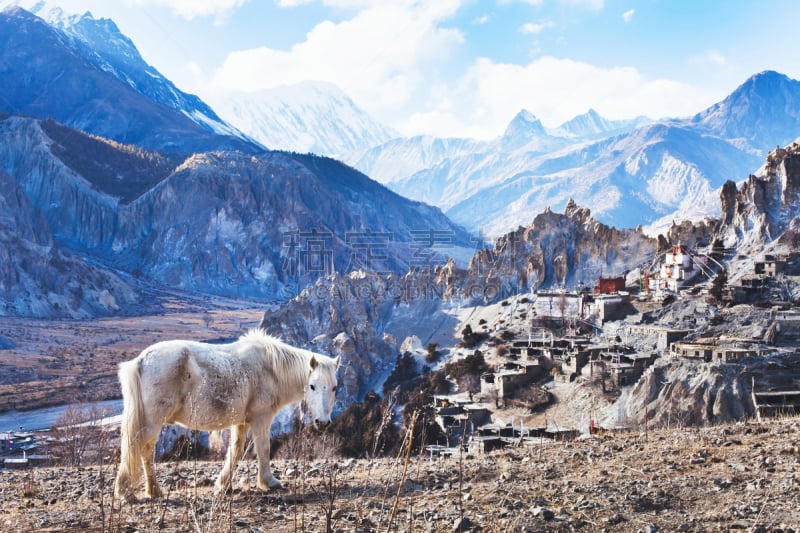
[0,115,470,316]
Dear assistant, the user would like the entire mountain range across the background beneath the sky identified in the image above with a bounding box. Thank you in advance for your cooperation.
[0,6,800,314]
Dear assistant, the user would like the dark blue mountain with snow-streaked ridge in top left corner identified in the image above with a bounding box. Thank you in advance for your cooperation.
[0,1,262,152]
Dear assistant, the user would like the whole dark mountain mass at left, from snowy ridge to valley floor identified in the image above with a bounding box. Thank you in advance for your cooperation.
[0,7,471,316]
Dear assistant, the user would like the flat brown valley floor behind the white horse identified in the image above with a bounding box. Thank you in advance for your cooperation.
[0,294,265,412]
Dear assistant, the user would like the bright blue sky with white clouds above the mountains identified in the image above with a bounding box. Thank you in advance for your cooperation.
[6,0,800,138]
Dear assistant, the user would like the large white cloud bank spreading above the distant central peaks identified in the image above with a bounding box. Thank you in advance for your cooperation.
[201,0,720,139]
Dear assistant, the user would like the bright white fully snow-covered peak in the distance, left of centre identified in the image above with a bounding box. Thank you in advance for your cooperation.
[212,81,397,157]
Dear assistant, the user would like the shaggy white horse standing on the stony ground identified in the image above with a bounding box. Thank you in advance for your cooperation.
[114,330,339,499]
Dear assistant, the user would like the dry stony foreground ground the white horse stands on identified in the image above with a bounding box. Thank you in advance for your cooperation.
[0,417,800,533]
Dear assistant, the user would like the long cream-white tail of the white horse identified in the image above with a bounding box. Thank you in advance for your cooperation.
[116,358,145,497]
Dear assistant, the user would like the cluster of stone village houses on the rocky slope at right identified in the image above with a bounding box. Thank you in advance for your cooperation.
[427,245,800,455]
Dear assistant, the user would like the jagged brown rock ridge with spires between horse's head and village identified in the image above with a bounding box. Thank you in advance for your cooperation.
[261,203,657,406]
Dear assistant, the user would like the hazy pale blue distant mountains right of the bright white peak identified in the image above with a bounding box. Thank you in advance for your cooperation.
[347,72,800,236]
